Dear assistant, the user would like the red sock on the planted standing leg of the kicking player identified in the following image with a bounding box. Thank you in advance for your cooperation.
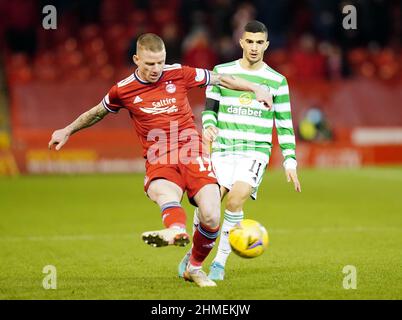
[190,223,219,266]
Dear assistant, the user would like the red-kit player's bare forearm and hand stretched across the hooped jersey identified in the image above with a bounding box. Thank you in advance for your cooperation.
[209,71,272,109]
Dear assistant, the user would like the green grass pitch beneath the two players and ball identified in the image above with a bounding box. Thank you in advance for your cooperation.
[0,168,402,299]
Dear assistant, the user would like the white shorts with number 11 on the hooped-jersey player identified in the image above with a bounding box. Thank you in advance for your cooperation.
[211,153,268,200]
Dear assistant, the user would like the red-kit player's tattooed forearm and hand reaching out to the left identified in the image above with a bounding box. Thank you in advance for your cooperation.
[49,103,109,151]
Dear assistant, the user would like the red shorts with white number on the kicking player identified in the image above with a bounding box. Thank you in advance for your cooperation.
[144,156,218,204]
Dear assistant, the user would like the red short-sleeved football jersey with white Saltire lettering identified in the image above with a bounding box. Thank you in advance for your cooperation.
[102,64,210,157]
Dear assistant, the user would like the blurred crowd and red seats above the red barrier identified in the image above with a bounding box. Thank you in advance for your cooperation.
[0,0,402,81]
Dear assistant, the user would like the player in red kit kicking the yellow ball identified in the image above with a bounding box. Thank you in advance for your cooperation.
[49,33,272,287]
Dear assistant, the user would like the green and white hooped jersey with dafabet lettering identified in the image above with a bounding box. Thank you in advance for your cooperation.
[202,60,297,168]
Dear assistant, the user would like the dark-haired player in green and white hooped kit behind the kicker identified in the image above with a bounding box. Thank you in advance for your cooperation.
[179,21,301,280]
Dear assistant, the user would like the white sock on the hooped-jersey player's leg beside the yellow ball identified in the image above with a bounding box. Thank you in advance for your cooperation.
[214,209,244,266]
